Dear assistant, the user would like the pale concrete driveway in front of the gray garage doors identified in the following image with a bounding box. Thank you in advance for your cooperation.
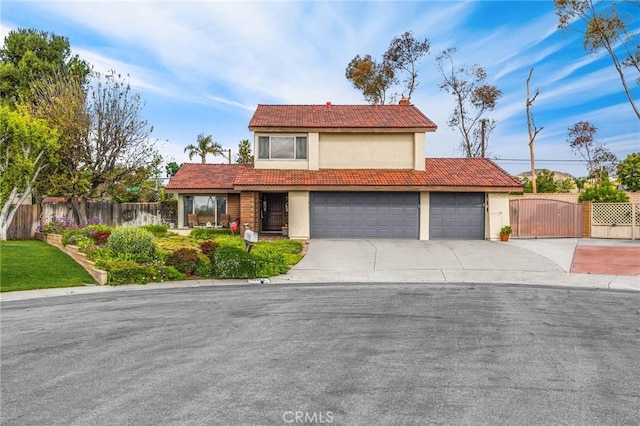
[272,238,640,290]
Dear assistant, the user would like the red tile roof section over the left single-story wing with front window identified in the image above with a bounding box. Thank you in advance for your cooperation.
[166,163,245,190]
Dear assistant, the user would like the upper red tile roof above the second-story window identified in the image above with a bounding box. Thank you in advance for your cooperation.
[249,103,437,131]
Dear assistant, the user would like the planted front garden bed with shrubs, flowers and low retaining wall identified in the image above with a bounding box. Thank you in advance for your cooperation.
[37,218,303,285]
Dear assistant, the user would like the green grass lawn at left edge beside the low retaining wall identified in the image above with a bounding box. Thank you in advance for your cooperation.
[0,240,95,291]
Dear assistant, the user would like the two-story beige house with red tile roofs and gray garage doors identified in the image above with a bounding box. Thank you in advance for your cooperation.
[167,99,522,240]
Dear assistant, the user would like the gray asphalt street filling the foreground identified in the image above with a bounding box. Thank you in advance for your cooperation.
[0,283,640,426]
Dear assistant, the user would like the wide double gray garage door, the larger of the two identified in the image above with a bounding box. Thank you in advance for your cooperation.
[311,192,420,239]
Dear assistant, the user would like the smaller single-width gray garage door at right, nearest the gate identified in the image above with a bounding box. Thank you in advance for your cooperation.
[429,192,484,240]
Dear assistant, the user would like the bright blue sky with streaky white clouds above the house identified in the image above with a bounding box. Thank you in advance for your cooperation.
[0,1,640,176]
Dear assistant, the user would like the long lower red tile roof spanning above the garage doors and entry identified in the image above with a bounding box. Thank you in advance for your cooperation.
[167,158,522,191]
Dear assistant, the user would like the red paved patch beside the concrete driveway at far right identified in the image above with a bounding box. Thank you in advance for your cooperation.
[571,245,640,275]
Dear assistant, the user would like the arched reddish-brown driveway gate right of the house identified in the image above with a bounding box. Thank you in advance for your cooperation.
[509,198,582,238]
